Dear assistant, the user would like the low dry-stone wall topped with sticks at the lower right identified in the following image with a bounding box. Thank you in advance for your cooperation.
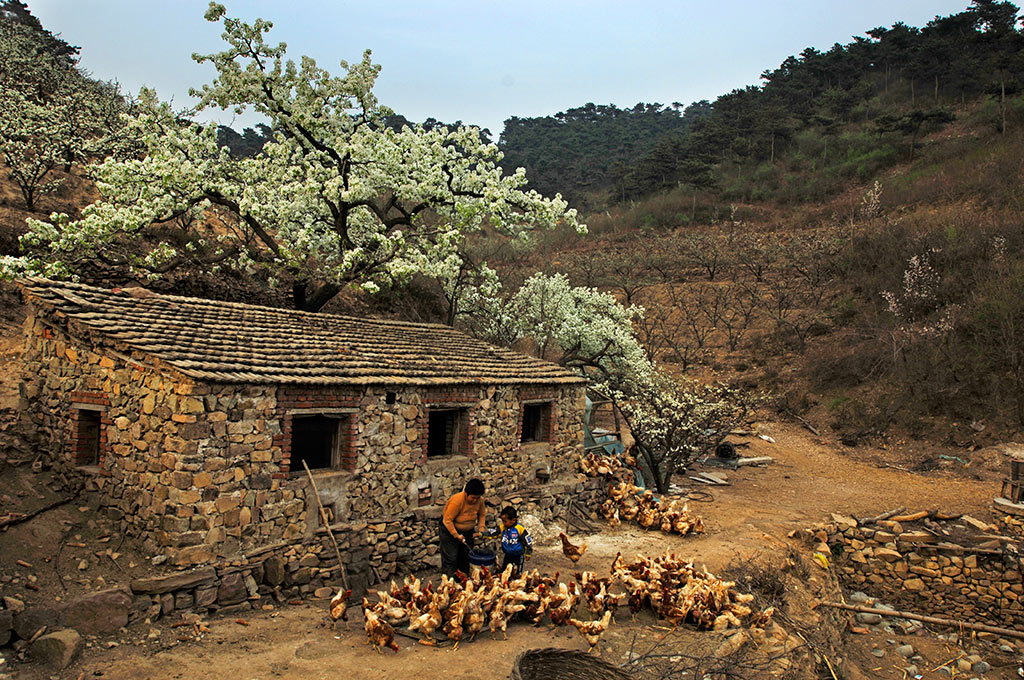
[817,515,1024,628]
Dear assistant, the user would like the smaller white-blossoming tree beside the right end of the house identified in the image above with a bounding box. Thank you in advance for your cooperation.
[476,273,750,493]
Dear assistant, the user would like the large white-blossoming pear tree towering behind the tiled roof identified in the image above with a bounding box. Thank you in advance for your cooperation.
[0,3,586,310]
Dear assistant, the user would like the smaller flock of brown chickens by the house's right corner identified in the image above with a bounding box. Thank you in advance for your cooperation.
[580,452,705,536]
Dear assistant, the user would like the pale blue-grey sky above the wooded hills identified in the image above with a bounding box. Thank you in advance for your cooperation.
[26,0,969,138]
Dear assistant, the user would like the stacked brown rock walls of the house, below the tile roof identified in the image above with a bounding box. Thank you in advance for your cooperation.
[23,307,600,569]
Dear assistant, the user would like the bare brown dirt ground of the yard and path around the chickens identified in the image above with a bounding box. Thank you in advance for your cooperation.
[8,423,1016,680]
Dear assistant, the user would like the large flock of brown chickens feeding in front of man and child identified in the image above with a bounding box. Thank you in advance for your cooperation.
[331,552,772,651]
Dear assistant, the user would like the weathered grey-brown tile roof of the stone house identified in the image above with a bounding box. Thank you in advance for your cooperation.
[19,279,583,385]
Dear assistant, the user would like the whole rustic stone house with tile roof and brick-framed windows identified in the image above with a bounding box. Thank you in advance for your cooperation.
[22,279,596,576]
